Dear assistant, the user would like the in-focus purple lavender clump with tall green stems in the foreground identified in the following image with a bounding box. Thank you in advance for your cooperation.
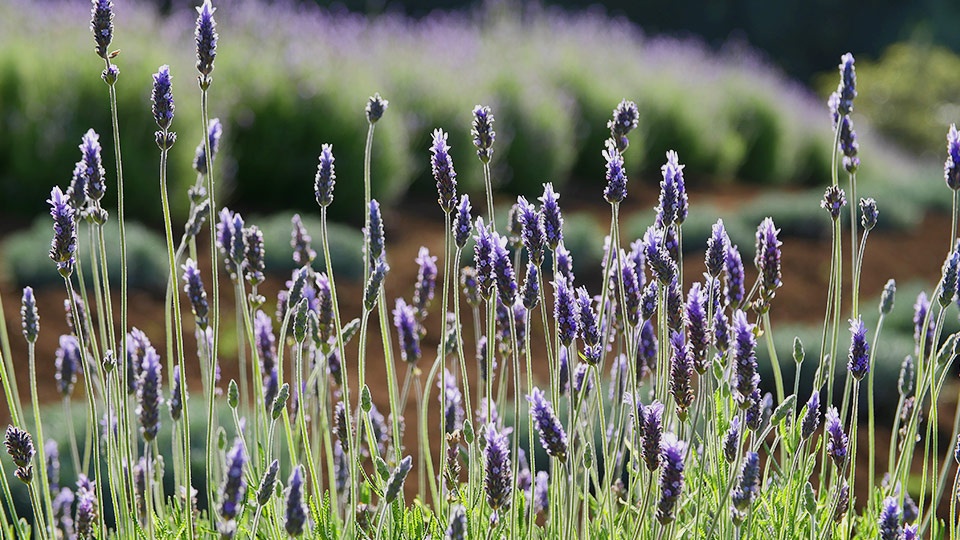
[0,0,960,539]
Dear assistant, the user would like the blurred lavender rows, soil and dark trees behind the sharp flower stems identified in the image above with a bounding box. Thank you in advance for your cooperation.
[0,0,960,516]
